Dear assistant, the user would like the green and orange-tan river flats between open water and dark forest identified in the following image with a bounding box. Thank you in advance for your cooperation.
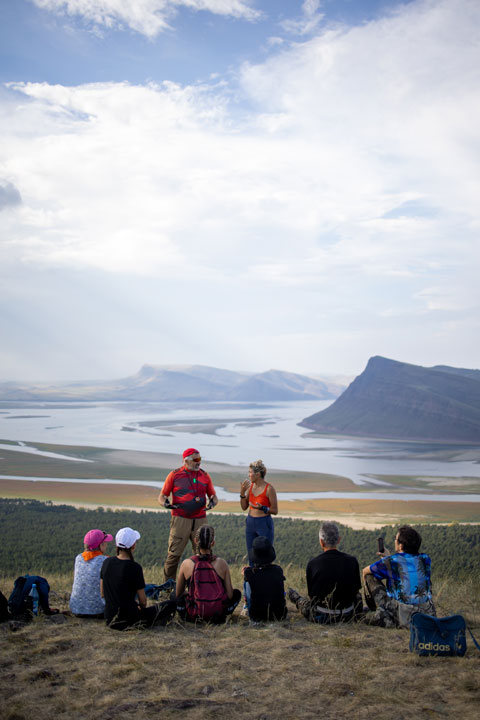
[0,443,480,528]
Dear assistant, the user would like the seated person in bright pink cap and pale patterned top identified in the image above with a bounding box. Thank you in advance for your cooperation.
[70,530,113,618]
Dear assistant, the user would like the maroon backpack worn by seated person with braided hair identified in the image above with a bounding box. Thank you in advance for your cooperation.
[186,555,228,620]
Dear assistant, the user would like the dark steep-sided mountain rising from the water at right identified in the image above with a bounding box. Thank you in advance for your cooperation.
[299,356,480,444]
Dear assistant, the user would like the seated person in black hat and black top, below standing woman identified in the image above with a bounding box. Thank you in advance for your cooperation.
[243,535,287,622]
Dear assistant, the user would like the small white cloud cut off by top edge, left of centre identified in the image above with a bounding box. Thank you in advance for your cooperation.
[32,0,261,38]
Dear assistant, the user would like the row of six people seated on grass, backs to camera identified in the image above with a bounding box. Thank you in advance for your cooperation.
[65,522,436,630]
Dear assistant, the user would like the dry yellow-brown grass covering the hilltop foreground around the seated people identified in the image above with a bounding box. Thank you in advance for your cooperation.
[0,567,480,720]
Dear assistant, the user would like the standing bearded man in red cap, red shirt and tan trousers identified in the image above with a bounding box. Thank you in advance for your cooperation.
[158,448,218,580]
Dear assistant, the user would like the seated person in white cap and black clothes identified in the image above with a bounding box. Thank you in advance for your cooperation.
[100,527,176,630]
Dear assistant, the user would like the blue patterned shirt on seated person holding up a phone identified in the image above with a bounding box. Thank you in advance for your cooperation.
[370,553,432,605]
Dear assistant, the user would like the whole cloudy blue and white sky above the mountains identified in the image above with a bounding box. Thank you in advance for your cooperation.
[0,0,480,381]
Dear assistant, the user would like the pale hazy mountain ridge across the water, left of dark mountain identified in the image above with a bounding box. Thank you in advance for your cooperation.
[0,365,344,402]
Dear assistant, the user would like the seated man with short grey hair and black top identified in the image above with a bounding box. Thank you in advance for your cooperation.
[288,522,362,623]
